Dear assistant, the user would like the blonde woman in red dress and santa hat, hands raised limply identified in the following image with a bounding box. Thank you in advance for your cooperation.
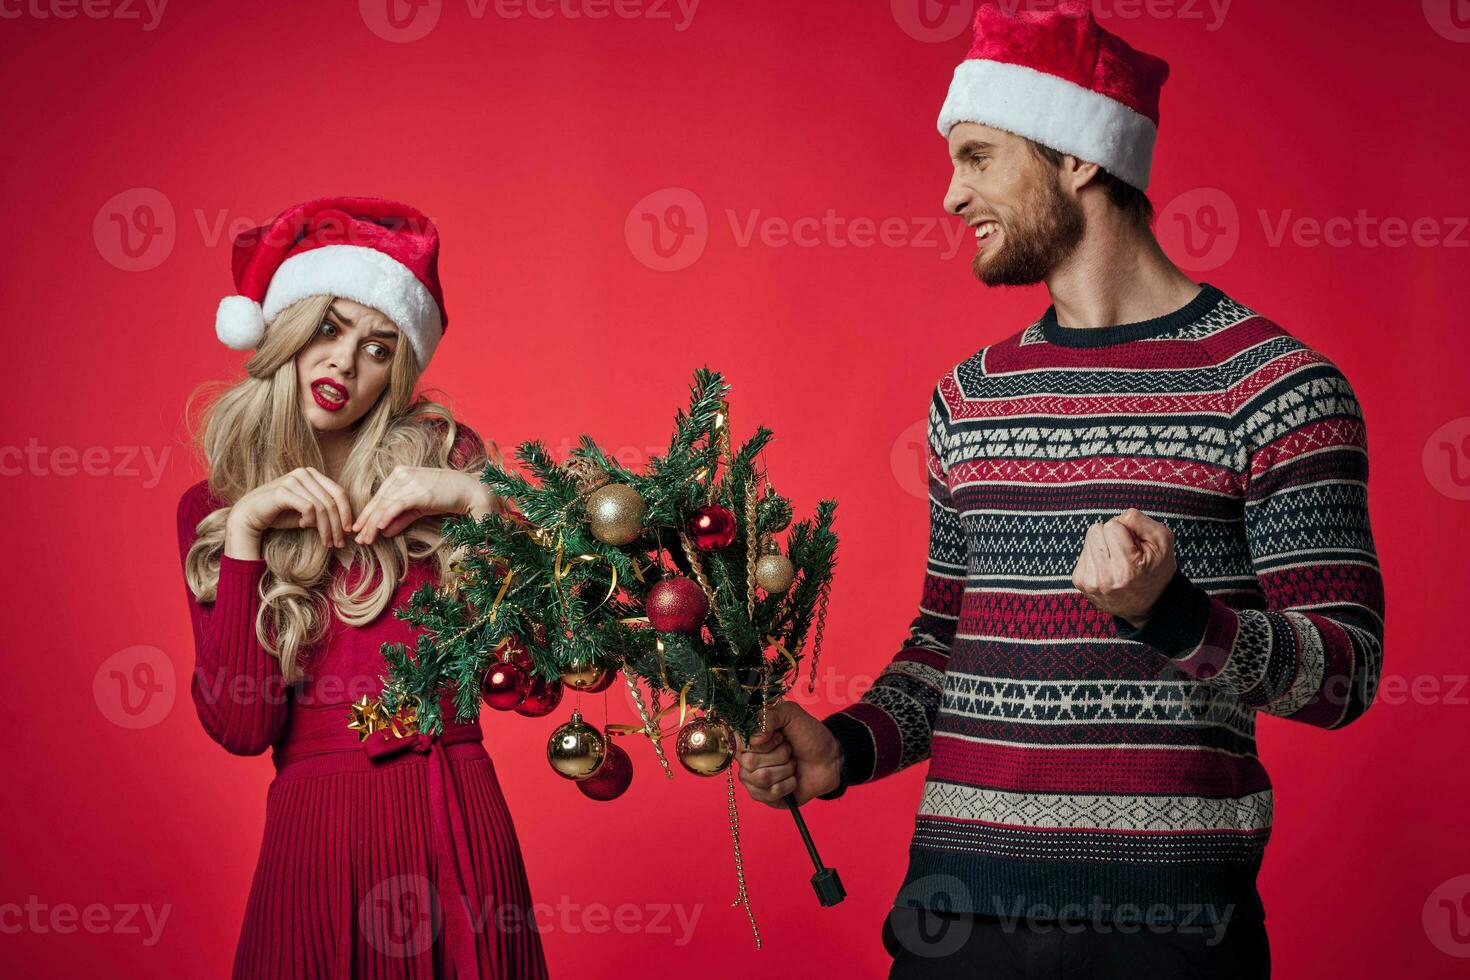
[178,198,545,980]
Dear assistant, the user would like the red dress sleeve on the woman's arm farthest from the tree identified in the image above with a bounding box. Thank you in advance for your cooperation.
[178,482,288,755]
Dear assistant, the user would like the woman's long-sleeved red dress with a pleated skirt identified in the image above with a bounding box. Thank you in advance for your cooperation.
[178,482,547,980]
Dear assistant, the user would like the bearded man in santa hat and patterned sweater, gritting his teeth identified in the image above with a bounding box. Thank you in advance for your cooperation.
[739,3,1383,980]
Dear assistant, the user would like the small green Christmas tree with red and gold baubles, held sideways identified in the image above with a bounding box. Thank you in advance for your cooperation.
[353,369,844,945]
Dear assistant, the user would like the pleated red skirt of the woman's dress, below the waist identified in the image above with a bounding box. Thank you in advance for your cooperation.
[232,705,547,980]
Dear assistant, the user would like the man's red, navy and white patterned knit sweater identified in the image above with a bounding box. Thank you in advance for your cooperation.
[826,284,1383,926]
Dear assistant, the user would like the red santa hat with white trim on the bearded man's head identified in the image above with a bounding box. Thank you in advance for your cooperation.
[939,0,1169,191]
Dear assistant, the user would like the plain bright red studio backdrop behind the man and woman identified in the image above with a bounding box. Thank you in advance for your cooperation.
[0,0,1470,980]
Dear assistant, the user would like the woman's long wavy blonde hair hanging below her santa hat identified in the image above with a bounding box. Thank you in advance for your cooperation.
[184,295,501,683]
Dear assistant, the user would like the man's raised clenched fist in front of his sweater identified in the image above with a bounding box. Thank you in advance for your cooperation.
[1072,507,1177,627]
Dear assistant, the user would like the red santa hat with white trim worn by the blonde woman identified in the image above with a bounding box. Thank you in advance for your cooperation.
[215,197,448,370]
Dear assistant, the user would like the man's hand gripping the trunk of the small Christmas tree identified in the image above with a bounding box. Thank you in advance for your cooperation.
[736,701,842,807]
